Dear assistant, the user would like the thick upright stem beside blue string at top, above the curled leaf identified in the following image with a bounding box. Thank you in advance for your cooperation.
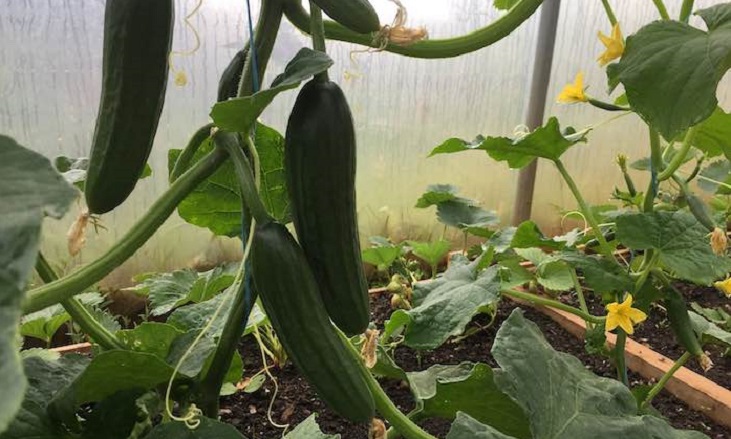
[237,0,285,97]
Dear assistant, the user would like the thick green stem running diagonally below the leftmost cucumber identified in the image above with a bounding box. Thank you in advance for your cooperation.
[23,149,227,314]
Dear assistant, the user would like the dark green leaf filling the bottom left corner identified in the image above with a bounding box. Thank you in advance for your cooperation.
[0,354,89,439]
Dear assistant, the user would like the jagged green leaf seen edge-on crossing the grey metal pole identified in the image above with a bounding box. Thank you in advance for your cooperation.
[429,117,585,168]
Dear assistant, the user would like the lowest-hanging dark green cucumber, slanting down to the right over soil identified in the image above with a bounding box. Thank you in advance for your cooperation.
[251,222,374,422]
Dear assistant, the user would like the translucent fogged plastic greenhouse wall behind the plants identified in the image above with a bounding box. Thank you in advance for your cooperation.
[0,0,731,285]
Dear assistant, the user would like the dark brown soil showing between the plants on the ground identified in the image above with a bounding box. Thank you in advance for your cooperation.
[221,295,731,439]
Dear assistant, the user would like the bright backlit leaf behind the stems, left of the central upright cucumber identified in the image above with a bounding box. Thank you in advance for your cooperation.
[168,124,290,237]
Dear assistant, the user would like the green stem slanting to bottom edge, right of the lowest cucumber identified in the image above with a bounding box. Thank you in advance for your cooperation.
[335,328,437,439]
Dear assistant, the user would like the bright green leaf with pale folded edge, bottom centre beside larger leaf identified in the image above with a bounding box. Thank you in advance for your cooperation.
[407,363,531,439]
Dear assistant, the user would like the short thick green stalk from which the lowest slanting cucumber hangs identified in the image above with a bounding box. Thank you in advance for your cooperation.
[213,131,272,224]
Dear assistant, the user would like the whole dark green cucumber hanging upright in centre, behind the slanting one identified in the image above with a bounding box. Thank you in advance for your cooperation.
[284,80,369,335]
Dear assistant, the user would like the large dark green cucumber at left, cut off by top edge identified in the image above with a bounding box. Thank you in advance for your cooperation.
[85,0,174,214]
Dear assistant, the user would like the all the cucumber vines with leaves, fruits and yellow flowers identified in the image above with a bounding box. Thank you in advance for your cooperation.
[0,0,731,439]
